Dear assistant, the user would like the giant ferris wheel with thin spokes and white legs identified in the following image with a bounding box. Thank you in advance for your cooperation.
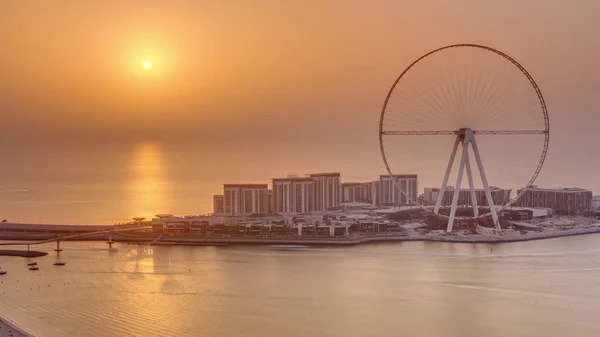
[379,44,550,232]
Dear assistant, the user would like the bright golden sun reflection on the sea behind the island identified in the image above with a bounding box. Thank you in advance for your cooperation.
[128,143,172,218]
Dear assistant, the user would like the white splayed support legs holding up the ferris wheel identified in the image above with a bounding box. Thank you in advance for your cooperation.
[434,128,501,232]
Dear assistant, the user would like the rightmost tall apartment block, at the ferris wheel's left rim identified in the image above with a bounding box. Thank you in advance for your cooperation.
[379,174,417,206]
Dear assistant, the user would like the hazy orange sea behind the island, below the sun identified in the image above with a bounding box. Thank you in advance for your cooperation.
[0,142,247,224]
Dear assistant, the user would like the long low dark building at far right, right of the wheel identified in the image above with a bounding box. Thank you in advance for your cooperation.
[514,186,592,215]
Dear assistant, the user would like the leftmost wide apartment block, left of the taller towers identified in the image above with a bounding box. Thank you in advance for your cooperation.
[223,184,269,215]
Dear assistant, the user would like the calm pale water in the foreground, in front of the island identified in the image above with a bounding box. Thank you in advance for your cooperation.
[0,235,600,337]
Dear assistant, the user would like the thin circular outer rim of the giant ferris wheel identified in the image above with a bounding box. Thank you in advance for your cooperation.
[379,43,550,219]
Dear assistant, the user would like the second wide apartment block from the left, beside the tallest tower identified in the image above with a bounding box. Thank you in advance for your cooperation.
[272,177,316,213]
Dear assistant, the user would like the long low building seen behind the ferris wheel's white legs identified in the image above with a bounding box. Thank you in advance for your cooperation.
[423,186,512,206]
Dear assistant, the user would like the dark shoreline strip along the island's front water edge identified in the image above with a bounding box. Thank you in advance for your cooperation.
[0,226,600,246]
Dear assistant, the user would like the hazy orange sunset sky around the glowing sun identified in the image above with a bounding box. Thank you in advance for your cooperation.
[0,0,600,192]
